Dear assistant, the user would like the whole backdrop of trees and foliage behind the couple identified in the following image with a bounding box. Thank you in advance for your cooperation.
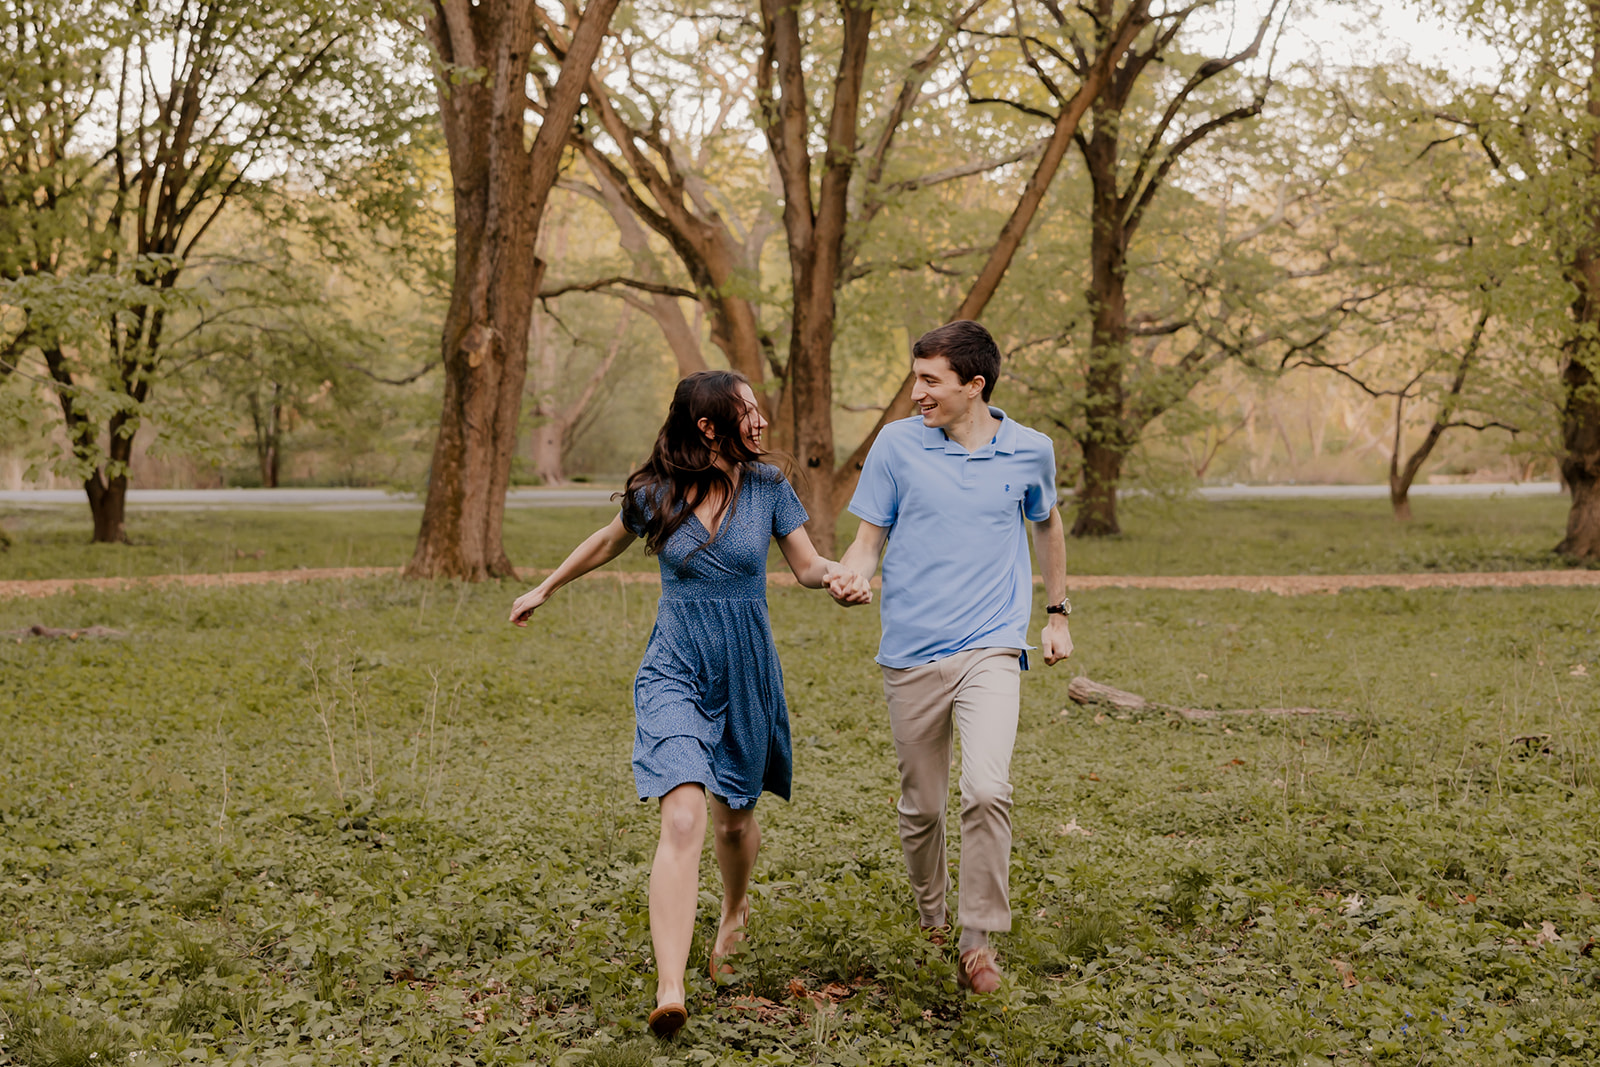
[0,0,1600,559]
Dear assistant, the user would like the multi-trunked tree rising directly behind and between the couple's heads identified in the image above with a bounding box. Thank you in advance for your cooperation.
[569,0,1150,550]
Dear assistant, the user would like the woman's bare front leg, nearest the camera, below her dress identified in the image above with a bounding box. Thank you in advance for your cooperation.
[650,784,706,1005]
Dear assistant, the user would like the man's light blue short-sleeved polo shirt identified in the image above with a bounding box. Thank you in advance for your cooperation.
[850,408,1056,669]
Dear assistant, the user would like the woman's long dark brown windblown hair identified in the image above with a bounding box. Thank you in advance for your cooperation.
[622,371,762,555]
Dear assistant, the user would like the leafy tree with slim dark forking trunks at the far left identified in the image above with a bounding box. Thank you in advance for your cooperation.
[0,0,425,541]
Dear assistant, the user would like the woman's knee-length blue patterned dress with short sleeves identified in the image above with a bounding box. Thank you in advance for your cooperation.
[624,464,806,809]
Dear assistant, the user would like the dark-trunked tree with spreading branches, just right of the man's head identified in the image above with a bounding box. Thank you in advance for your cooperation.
[992,0,1288,537]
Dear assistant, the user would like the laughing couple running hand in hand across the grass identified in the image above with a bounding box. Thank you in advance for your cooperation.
[510,320,1072,1037]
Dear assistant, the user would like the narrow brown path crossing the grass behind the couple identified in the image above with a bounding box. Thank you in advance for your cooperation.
[0,566,1600,600]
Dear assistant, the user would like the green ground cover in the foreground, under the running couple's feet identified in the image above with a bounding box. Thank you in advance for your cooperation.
[0,579,1600,1067]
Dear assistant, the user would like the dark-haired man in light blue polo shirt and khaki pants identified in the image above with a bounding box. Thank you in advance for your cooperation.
[829,322,1072,993]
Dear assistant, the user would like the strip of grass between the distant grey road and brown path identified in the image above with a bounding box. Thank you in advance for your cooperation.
[0,498,1566,581]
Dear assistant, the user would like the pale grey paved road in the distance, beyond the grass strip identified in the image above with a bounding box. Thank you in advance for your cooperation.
[0,482,1562,512]
